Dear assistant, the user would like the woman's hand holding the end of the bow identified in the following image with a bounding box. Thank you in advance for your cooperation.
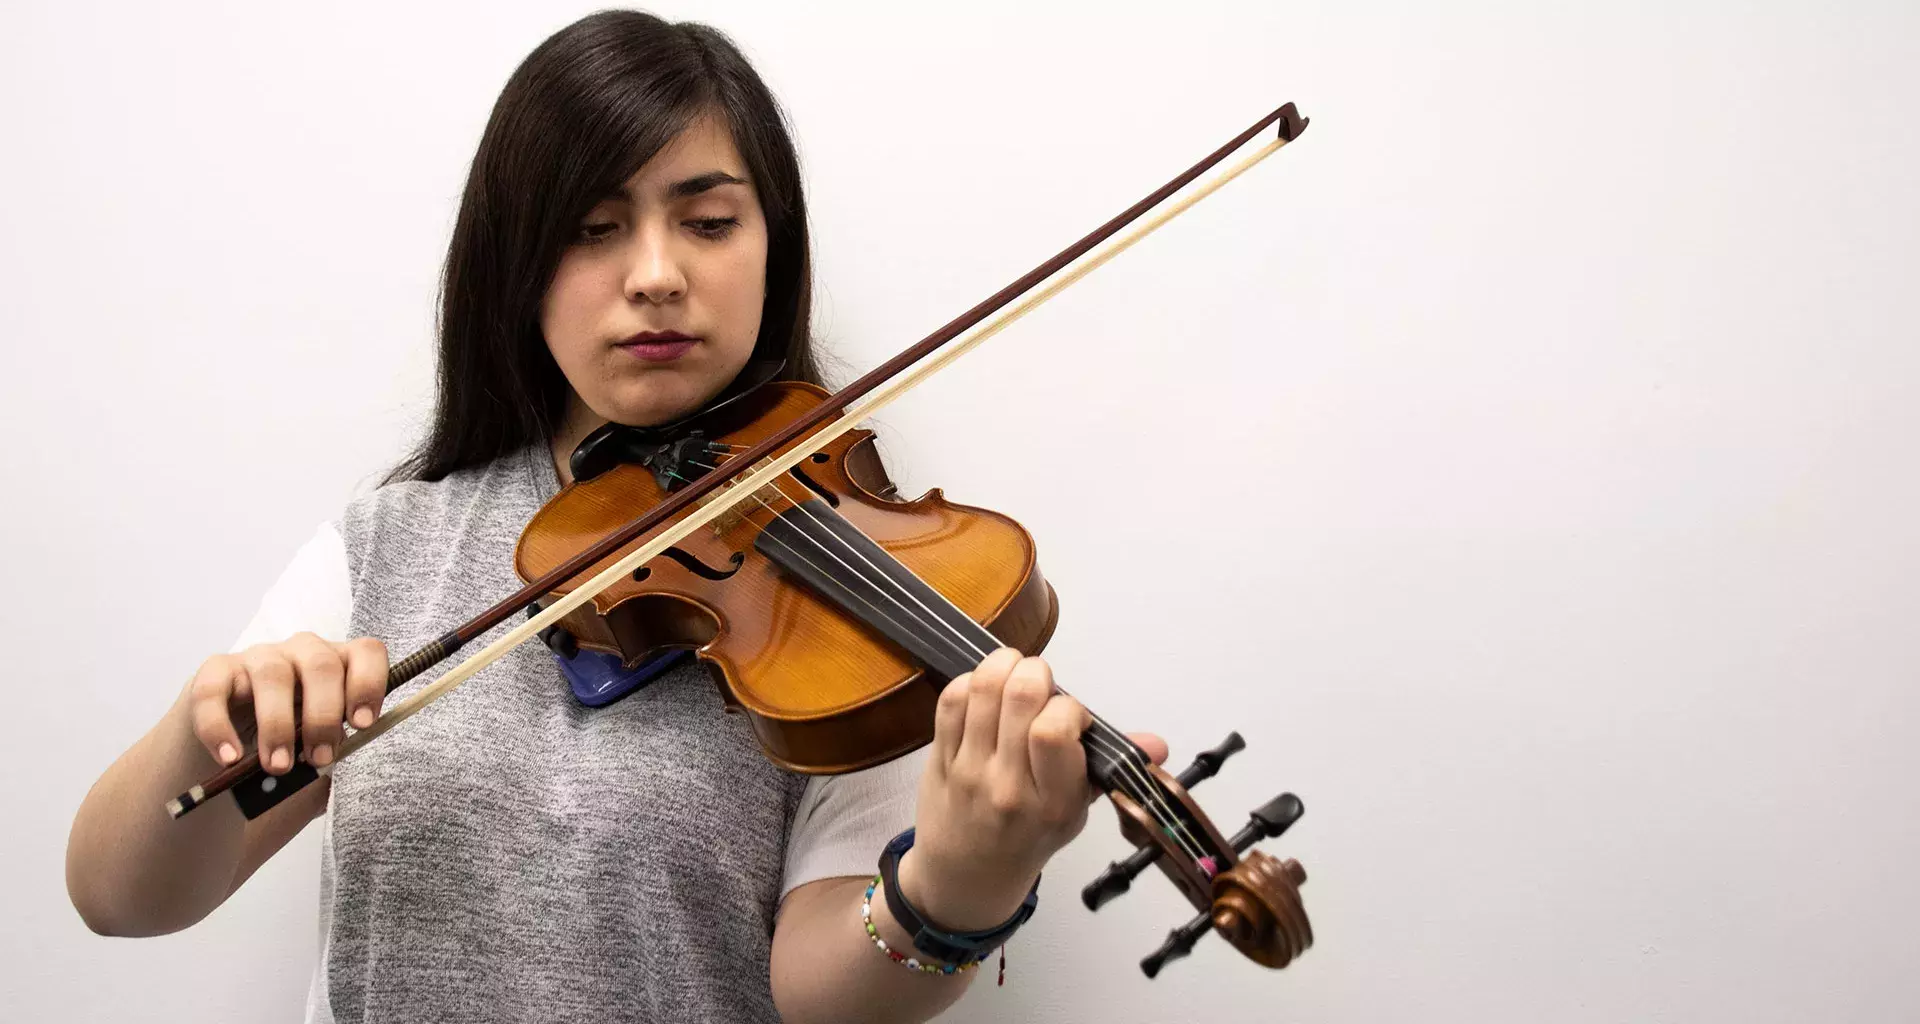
[186,632,386,774]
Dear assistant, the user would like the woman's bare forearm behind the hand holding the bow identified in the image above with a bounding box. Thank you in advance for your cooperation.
[67,701,246,936]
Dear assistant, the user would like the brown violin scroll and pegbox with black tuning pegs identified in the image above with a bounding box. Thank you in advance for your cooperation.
[1081,732,1313,978]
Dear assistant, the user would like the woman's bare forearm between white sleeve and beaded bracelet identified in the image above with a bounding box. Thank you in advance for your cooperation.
[772,878,981,1024]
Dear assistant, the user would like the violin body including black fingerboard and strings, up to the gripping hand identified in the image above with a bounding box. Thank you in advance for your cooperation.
[515,380,1060,774]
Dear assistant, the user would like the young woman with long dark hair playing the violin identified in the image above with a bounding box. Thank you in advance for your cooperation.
[67,12,1164,1022]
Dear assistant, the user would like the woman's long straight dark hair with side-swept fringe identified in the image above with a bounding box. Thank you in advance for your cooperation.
[386,12,820,480]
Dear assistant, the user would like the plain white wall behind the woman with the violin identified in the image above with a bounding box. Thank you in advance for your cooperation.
[0,2,1920,1024]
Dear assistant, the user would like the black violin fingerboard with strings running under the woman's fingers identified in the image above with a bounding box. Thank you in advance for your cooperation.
[755,498,1146,792]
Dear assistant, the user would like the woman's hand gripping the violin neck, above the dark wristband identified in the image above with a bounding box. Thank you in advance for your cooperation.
[899,647,1167,932]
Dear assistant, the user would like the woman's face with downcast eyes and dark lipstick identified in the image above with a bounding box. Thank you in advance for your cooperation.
[540,117,766,432]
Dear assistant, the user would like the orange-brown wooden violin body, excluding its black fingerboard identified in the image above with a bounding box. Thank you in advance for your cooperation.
[515,382,1058,774]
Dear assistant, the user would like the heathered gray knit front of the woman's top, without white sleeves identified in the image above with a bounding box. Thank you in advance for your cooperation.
[321,448,804,1024]
